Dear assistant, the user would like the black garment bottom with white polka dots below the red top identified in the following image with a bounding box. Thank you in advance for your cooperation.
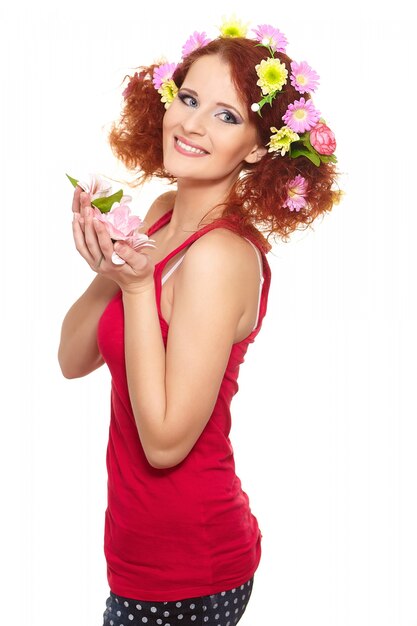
[103,578,253,626]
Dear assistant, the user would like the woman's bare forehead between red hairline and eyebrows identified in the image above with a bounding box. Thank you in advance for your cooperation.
[182,54,243,105]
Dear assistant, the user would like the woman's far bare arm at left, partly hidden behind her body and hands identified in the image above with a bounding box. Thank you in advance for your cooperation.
[58,188,172,378]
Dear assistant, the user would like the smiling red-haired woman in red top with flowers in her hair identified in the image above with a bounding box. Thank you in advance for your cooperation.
[59,19,337,626]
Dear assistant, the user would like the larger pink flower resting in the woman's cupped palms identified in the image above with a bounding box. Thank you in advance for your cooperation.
[93,202,155,265]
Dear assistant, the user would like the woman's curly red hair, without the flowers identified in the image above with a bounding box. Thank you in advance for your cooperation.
[109,37,341,251]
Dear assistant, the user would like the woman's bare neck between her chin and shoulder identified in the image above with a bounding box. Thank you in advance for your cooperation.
[167,168,236,237]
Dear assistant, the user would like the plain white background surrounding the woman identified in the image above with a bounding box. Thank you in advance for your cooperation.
[0,0,417,626]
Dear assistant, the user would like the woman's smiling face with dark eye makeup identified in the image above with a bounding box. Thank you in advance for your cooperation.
[163,55,266,182]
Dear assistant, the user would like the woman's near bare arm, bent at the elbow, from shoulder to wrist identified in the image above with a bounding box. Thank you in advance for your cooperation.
[123,231,254,468]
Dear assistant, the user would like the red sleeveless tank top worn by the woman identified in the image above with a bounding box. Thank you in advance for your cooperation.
[97,211,271,602]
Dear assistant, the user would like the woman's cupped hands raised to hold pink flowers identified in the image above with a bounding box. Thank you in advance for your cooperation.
[72,187,154,293]
